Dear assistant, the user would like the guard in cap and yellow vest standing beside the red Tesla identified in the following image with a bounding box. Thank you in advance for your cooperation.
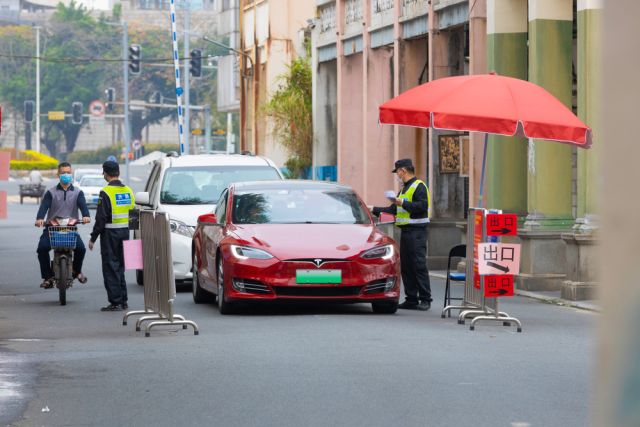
[373,159,431,311]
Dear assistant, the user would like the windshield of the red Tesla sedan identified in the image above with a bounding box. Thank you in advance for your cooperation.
[232,188,371,224]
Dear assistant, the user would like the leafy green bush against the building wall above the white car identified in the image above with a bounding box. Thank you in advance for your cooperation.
[262,45,313,177]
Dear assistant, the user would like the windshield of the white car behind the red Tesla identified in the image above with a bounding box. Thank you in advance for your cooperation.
[160,166,280,205]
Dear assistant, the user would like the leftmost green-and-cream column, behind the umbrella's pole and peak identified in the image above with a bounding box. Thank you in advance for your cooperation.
[488,0,528,216]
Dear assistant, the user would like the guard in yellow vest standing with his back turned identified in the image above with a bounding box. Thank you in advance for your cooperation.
[89,161,134,311]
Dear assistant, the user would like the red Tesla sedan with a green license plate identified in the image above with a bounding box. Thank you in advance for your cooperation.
[193,180,400,314]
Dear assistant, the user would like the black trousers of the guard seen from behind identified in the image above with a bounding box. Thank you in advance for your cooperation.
[100,228,129,304]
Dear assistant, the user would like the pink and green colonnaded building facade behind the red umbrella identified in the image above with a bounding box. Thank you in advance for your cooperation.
[312,0,602,299]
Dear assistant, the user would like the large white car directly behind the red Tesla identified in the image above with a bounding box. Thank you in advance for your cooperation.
[134,154,284,285]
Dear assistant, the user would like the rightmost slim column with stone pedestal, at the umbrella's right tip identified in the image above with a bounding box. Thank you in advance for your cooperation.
[562,0,603,300]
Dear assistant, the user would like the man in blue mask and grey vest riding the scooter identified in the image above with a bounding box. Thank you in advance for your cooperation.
[36,162,91,289]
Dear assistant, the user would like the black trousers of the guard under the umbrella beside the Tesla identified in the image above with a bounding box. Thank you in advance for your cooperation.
[400,226,431,303]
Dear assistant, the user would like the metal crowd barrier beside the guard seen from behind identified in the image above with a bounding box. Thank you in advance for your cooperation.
[122,211,199,337]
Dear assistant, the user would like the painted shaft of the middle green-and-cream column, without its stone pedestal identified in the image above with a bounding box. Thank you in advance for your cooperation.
[525,0,573,230]
